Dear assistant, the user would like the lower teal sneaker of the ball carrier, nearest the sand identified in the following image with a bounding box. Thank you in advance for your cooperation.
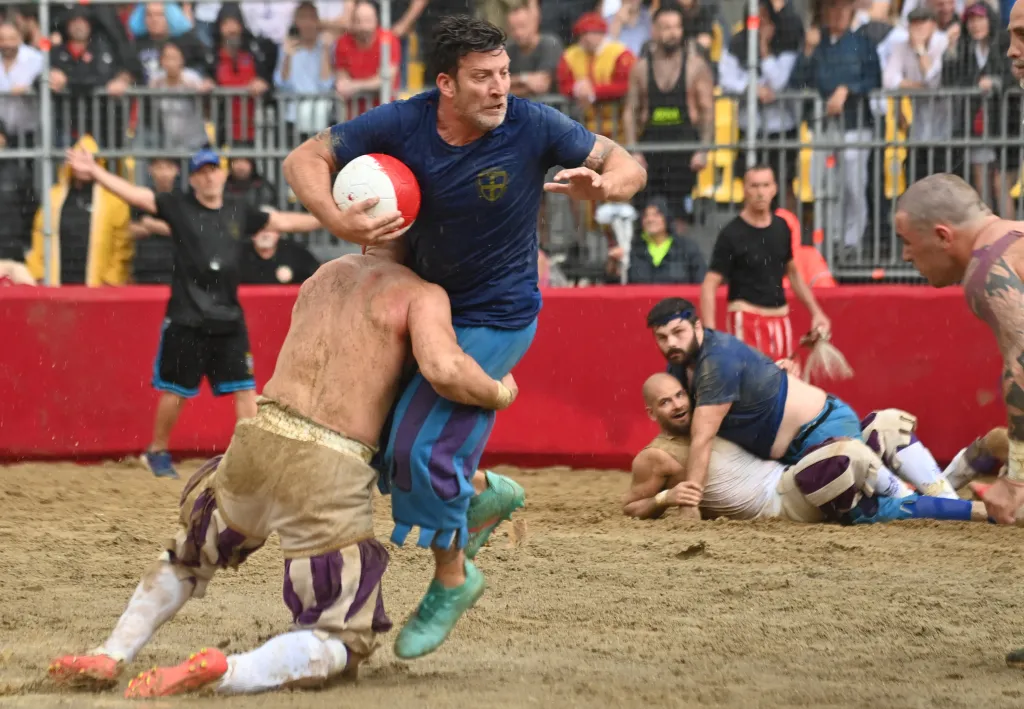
[394,561,487,660]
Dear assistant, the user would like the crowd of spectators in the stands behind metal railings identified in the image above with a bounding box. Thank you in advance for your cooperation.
[0,0,1021,284]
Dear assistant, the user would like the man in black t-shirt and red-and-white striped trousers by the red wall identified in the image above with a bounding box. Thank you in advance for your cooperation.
[700,165,831,361]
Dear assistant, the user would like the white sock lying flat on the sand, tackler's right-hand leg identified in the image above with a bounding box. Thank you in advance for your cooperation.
[217,630,348,694]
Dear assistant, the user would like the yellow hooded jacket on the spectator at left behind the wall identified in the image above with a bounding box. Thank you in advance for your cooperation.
[25,135,135,287]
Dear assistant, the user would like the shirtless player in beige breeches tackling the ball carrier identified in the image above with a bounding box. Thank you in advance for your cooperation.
[50,242,525,698]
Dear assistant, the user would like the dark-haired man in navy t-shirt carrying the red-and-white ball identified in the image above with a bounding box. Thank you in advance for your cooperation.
[285,15,647,658]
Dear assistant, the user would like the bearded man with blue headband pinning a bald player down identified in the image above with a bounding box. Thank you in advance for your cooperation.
[647,298,956,505]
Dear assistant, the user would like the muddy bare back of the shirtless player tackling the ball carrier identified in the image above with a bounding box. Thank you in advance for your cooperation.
[263,254,422,446]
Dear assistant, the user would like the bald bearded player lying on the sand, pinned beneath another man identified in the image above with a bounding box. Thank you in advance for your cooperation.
[623,374,1006,524]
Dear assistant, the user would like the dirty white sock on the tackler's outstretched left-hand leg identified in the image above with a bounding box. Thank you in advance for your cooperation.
[92,559,193,662]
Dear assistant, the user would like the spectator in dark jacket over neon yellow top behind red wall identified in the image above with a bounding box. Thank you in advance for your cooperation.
[628,197,708,284]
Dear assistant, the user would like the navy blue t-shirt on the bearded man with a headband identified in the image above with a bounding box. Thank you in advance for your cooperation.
[669,329,790,460]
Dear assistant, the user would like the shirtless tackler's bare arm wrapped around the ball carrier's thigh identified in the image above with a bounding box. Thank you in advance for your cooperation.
[409,284,517,410]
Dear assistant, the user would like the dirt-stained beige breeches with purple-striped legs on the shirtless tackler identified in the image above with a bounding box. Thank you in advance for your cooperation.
[167,399,391,656]
